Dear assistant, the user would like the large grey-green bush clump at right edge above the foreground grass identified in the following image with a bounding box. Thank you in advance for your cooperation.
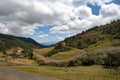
[89,47,120,66]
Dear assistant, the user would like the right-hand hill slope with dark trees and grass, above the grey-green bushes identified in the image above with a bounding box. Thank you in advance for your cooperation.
[63,20,120,49]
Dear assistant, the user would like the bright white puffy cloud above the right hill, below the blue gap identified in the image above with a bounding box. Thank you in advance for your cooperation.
[50,0,120,34]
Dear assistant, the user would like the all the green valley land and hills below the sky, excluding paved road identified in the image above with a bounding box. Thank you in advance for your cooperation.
[0,20,120,80]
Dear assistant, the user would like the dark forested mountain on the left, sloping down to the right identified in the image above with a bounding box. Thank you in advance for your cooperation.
[0,34,45,51]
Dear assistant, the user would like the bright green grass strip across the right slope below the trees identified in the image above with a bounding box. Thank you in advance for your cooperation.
[84,39,120,51]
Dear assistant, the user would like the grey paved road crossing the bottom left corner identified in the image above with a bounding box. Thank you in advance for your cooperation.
[0,68,53,80]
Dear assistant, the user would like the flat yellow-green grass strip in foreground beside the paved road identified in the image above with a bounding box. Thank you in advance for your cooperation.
[4,65,120,80]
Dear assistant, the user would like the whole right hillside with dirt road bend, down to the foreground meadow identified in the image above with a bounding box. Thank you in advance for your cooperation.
[32,20,120,66]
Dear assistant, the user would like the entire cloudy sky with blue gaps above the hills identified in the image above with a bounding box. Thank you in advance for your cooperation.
[0,0,120,44]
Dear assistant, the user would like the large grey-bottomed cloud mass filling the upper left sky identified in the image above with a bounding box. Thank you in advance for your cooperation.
[0,0,72,35]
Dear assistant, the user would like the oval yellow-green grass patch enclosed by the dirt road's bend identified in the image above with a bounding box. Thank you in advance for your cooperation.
[50,48,80,60]
